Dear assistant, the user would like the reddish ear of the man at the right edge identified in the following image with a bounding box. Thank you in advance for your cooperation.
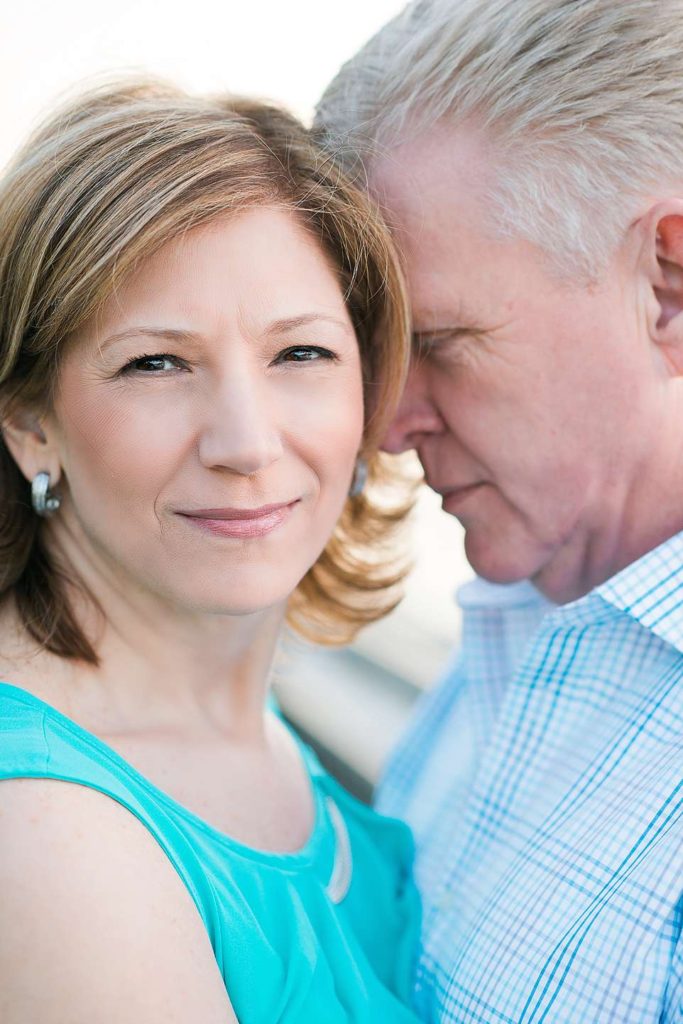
[640,199,683,376]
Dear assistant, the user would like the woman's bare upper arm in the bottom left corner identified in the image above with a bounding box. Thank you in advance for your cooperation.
[0,779,237,1024]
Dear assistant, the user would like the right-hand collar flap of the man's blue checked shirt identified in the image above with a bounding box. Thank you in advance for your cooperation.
[593,532,683,651]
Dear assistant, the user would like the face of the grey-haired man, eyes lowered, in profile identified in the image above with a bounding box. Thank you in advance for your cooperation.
[372,130,666,601]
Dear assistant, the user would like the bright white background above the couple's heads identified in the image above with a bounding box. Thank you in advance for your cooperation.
[0,0,411,163]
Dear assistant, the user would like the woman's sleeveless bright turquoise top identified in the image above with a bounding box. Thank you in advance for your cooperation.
[0,683,420,1024]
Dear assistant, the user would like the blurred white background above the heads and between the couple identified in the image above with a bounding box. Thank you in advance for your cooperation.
[0,0,470,790]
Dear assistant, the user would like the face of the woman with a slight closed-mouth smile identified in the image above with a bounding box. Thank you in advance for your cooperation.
[48,208,364,614]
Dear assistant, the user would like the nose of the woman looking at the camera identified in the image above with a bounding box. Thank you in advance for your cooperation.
[199,373,283,476]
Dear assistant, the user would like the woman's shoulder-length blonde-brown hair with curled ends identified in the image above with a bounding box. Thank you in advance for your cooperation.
[0,82,411,664]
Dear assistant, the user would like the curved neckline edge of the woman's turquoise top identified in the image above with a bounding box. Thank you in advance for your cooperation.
[0,680,331,870]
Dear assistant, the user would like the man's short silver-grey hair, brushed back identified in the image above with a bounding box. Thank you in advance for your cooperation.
[315,0,683,278]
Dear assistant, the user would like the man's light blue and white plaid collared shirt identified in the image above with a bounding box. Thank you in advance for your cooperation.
[379,534,683,1024]
